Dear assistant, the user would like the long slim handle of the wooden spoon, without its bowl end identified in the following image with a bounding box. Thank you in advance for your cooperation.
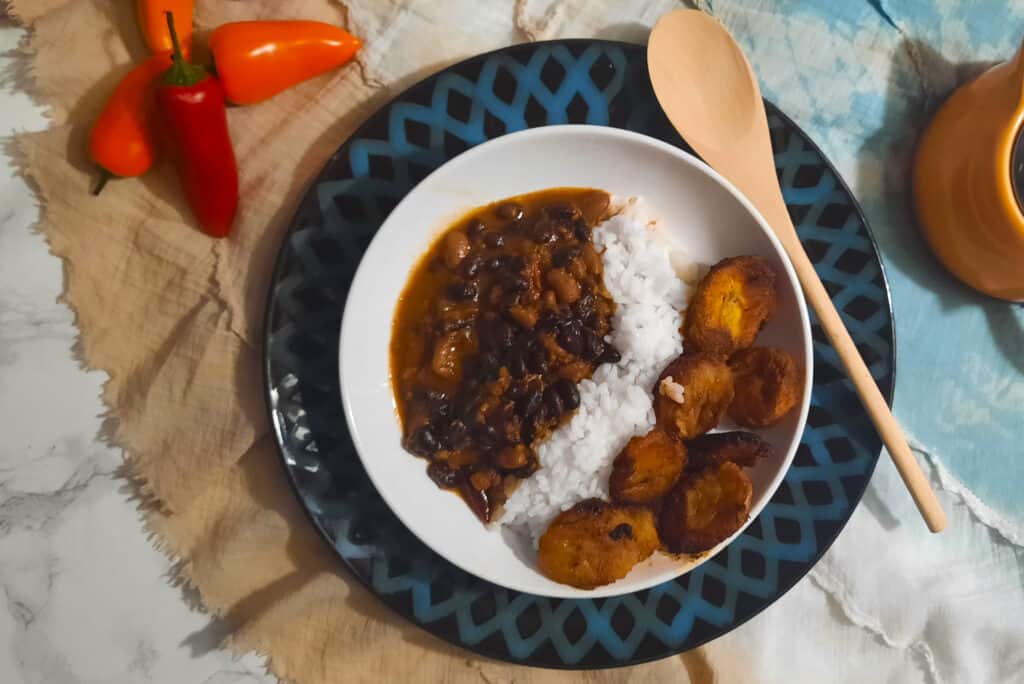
[778,227,946,532]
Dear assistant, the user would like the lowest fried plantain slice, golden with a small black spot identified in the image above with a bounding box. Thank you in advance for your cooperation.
[537,499,660,589]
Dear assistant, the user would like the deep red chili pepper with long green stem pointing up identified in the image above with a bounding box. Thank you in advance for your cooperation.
[157,12,239,238]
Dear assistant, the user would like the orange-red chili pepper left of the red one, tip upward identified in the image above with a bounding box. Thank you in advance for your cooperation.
[89,52,171,194]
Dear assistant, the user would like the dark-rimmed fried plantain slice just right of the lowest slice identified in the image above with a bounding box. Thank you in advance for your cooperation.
[658,461,754,553]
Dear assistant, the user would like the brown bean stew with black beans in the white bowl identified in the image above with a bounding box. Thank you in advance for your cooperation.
[391,188,620,522]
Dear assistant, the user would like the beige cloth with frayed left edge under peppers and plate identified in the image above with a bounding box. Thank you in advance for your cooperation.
[8,0,721,684]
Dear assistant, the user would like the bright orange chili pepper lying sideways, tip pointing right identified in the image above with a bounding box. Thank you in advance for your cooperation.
[209,22,362,104]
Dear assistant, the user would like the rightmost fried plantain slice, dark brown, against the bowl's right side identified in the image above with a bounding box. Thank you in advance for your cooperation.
[729,347,804,427]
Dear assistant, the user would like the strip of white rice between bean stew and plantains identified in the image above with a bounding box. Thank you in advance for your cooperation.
[501,199,690,545]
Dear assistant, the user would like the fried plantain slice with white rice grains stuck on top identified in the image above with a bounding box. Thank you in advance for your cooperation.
[654,354,733,439]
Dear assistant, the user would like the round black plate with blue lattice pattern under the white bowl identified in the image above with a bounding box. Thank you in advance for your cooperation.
[265,40,893,669]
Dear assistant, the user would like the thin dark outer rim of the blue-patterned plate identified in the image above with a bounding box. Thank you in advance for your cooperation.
[260,38,898,671]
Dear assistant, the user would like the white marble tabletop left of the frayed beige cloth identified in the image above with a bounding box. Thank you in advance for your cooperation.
[0,24,273,684]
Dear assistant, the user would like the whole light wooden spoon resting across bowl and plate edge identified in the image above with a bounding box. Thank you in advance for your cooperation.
[647,9,946,532]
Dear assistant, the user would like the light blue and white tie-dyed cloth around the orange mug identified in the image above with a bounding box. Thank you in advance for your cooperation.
[703,0,1024,528]
